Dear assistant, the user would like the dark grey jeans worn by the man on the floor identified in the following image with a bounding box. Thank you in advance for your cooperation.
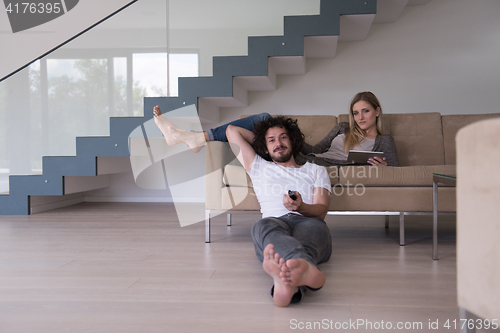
[252,213,332,267]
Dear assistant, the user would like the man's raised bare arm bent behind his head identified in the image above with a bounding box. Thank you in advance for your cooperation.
[226,125,255,172]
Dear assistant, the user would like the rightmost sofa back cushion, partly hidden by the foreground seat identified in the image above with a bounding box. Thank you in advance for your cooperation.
[442,113,500,165]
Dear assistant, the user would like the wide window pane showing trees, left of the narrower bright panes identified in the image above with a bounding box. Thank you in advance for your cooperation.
[42,59,110,156]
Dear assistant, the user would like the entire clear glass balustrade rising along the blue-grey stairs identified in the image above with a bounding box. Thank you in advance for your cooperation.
[0,0,319,193]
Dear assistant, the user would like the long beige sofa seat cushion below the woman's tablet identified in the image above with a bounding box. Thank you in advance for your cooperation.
[339,165,456,187]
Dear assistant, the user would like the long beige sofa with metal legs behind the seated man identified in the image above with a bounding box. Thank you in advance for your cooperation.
[205,113,499,241]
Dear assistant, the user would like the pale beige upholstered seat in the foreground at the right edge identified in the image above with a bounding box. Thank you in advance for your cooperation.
[456,119,500,319]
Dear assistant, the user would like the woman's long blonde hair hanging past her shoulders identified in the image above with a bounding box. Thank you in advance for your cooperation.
[344,91,383,152]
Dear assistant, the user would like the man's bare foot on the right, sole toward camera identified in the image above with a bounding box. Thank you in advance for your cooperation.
[280,259,326,289]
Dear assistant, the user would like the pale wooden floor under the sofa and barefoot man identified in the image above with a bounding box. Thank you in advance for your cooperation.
[0,203,458,333]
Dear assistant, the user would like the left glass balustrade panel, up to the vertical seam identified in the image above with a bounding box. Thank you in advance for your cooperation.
[0,0,168,193]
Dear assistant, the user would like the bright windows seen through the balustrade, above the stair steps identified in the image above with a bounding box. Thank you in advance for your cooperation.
[0,50,198,193]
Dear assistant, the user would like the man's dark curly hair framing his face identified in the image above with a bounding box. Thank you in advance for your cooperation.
[253,116,305,161]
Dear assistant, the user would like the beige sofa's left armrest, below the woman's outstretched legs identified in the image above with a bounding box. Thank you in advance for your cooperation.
[205,141,239,209]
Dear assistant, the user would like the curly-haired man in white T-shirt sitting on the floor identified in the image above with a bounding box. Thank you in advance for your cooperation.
[226,116,332,306]
